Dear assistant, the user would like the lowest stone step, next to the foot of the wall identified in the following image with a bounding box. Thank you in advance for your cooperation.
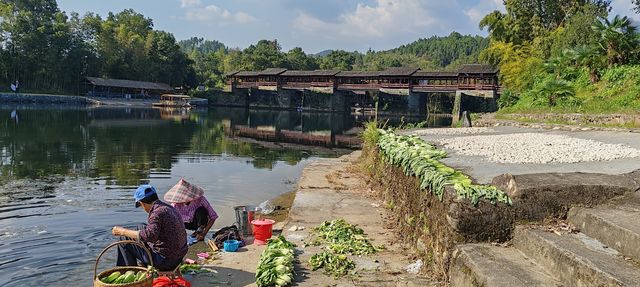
[449,244,563,287]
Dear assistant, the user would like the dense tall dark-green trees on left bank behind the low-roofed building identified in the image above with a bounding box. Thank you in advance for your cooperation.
[0,0,195,94]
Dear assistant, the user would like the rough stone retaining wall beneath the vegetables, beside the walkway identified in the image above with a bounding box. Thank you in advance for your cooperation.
[360,145,514,280]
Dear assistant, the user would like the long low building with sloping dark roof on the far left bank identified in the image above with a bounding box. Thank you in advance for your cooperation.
[84,77,173,99]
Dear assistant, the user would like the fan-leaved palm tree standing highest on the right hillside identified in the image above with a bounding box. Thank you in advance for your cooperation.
[591,15,638,66]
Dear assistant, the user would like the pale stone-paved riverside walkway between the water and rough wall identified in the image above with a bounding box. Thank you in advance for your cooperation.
[185,152,438,286]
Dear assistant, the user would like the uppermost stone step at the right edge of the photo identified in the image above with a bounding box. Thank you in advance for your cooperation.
[567,205,640,260]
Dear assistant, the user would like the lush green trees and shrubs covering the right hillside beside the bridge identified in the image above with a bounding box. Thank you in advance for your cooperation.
[480,0,640,112]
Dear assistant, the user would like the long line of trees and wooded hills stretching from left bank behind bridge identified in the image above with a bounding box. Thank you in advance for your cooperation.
[0,0,489,94]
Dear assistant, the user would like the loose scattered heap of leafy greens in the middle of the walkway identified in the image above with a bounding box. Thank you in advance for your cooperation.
[309,219,382,278]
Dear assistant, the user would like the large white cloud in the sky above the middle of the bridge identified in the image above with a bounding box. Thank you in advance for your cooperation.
[293,0,436,38]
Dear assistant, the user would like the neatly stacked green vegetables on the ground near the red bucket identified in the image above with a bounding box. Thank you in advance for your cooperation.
[256,235,295,287]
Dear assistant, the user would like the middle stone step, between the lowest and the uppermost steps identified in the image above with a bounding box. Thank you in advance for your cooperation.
[512,226,640,286]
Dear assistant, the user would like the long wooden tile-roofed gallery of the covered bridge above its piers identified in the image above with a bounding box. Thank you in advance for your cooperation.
[227,64,499,98]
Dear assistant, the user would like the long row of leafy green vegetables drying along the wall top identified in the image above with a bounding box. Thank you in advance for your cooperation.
[378,129,511,205]
